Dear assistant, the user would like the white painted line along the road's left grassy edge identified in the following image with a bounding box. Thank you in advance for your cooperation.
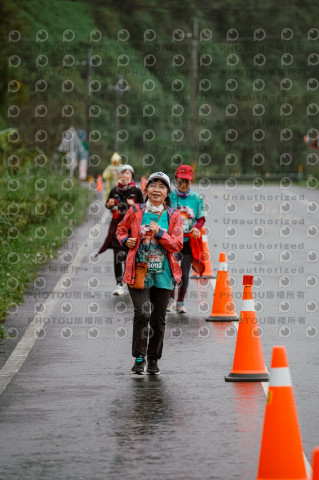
[0,212,108,395]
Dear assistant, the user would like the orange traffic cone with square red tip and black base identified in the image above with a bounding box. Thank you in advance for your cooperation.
[225,275,269,382]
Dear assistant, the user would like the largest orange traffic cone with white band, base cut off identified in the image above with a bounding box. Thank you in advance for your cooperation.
[256,346,308,480]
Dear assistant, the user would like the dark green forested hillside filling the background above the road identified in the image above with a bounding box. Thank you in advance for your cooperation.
[0,0,319,178]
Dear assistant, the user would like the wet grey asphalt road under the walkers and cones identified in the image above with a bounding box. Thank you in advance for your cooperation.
[0,184,319,480]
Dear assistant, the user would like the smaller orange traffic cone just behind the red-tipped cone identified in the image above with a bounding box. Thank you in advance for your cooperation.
[206,252,238,322]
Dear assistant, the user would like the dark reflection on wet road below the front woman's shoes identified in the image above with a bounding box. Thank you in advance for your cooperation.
[111,375,174,478]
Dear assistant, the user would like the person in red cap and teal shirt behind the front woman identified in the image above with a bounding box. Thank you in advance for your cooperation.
[167,165,205,313]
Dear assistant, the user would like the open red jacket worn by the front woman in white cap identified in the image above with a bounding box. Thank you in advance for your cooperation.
[116,203,183,284]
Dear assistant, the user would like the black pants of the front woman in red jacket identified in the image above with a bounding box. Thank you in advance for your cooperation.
[128,287,171,358]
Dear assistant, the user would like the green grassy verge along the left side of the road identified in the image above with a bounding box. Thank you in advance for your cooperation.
[0,136,94,339]
